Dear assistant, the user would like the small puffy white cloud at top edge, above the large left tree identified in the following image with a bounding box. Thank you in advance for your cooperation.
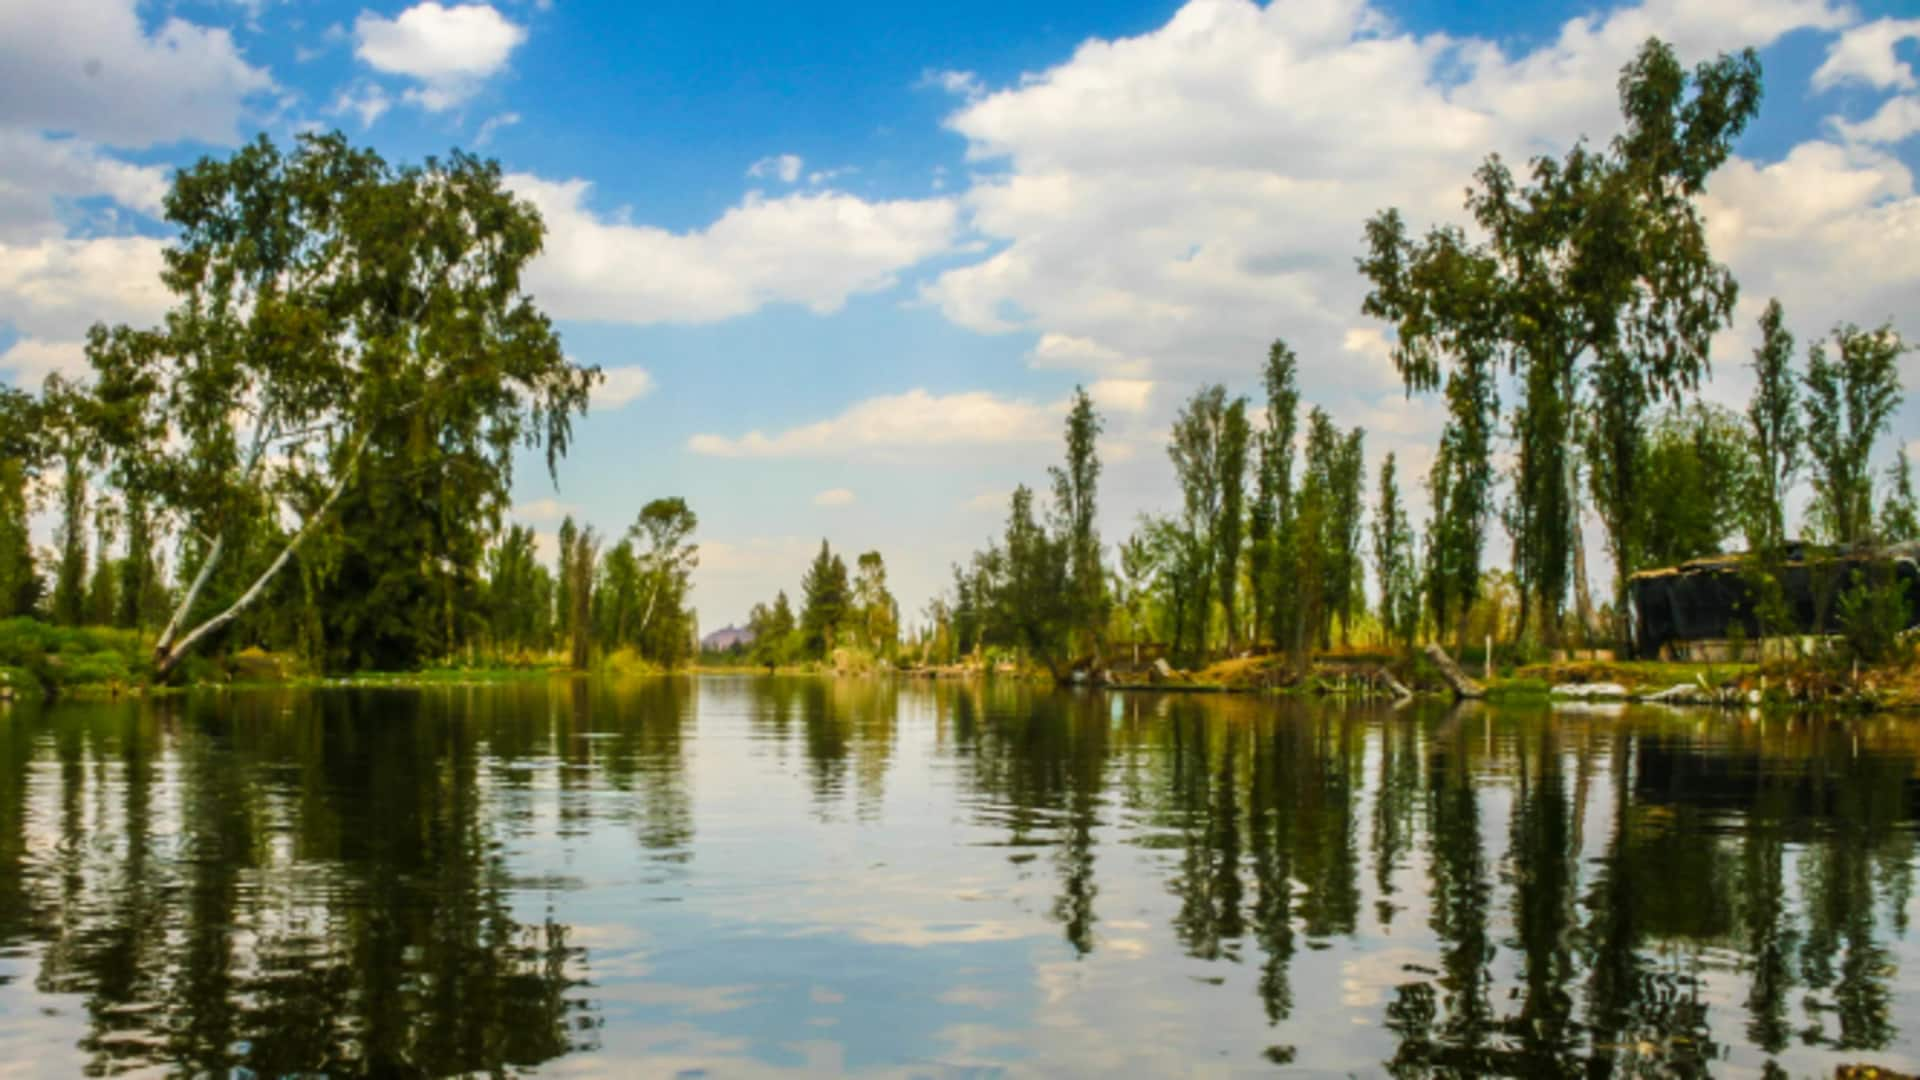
[353,0,526,111]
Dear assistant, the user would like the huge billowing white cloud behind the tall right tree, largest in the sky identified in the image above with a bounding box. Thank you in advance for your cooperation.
[924,0,1843,411]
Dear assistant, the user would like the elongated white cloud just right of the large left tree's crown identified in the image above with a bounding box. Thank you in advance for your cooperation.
[507,175,956,323]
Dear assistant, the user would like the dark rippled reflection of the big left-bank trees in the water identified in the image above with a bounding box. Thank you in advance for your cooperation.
[0,694,593,1076]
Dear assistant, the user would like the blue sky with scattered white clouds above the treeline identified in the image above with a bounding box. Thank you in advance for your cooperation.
[0,0,1920,628]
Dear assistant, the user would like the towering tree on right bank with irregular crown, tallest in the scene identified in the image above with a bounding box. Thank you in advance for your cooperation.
[1361,40,1761,638]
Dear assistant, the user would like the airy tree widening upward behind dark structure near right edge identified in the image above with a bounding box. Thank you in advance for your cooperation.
[1807,317,1907,548]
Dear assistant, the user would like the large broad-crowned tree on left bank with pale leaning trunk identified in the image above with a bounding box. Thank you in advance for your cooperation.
[86,133,599,671]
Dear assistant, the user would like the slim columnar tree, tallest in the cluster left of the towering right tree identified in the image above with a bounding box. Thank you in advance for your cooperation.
[1248,340,1300,646]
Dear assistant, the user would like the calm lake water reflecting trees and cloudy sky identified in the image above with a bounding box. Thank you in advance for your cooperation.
[0,678,1920,1076]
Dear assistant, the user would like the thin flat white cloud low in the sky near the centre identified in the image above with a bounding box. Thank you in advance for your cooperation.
[687,390,1064,457]
